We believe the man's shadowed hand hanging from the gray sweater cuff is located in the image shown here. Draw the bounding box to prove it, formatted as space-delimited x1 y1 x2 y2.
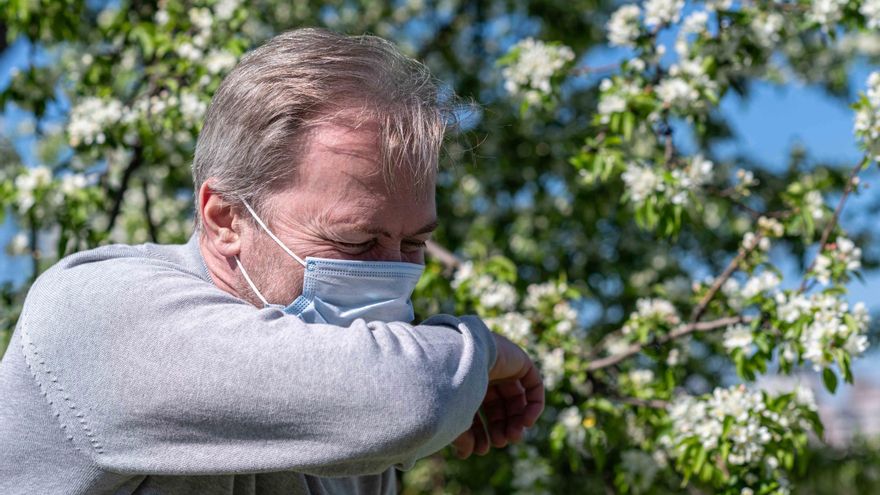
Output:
452 333 544 459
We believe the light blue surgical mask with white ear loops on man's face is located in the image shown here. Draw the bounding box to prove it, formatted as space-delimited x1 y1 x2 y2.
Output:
235 202 425 326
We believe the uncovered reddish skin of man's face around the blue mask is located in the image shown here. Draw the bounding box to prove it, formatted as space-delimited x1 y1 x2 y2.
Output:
237 120 437 305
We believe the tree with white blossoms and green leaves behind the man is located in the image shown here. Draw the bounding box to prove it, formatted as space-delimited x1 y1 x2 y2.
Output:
0 0 880 494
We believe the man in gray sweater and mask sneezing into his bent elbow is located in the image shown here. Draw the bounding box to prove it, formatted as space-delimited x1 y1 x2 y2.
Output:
0 29 544 494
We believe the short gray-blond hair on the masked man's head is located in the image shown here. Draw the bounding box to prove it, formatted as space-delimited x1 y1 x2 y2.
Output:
193 28 453 228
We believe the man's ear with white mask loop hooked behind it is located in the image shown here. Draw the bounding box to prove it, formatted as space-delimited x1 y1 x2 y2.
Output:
199 179 243 258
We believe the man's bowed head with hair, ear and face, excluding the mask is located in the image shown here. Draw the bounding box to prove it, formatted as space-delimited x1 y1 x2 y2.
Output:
193 29 447 304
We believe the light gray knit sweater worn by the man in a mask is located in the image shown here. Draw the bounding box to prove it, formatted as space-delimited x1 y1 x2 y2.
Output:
0 237 496 495
